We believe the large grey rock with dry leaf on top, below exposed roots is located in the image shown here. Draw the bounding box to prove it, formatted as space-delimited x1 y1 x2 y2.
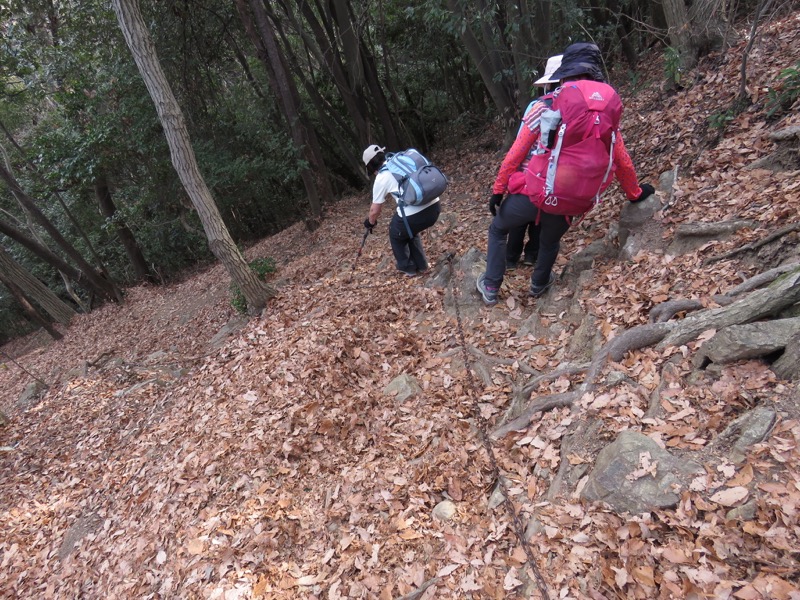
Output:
581 430 703 514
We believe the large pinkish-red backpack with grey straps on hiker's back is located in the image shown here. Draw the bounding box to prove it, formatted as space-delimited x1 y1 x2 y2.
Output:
525 80 622 216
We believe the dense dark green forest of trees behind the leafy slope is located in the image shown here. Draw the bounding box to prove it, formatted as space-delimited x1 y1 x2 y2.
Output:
0 0 780 336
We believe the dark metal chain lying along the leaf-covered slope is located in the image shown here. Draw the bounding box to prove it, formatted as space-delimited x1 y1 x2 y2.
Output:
442 254 550 600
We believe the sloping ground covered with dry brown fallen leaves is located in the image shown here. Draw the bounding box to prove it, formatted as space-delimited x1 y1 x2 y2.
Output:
0 15 800 600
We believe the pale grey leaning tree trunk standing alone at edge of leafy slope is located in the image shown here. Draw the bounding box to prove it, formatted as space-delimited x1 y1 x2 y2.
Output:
112 0 275 315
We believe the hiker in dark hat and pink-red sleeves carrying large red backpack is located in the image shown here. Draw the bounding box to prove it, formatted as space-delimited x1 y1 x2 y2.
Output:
477 43 655 306
